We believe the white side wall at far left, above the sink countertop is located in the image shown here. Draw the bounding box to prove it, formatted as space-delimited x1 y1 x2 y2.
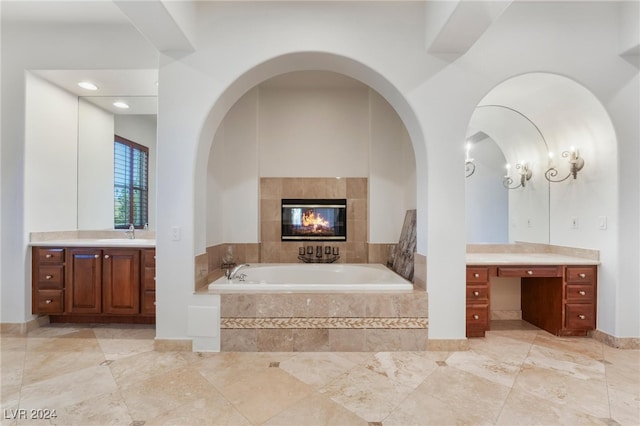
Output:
24 73 78 234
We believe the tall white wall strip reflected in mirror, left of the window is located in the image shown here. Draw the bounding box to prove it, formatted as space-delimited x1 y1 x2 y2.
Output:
76 99 114 229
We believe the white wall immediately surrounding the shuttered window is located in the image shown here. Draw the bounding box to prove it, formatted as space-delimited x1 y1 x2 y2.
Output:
114 114 158 229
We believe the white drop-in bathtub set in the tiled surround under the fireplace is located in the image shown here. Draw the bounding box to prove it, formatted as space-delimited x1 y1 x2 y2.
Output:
208 263 413 292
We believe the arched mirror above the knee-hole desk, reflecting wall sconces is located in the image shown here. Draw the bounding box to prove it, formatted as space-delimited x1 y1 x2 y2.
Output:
466 96 549 244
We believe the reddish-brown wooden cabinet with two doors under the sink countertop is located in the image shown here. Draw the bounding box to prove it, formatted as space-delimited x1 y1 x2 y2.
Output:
32 247 155 322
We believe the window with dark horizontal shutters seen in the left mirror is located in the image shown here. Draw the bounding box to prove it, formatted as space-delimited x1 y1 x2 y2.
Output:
113 135 149 229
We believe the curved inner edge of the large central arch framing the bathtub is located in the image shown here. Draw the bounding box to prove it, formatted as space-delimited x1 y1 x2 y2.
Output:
194 52 426 260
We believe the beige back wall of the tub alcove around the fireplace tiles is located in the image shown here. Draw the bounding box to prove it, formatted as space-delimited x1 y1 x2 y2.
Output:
207 84 415 246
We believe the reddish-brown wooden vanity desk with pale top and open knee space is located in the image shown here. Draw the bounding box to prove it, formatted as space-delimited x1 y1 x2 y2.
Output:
466 253 598 337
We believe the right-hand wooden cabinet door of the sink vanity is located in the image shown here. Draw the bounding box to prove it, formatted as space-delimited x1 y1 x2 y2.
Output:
102 249 140 314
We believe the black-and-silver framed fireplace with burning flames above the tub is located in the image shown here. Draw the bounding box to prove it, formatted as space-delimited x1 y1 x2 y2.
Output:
282 198 347 241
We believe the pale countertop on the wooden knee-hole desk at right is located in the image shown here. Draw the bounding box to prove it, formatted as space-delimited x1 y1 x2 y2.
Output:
467 253 600 266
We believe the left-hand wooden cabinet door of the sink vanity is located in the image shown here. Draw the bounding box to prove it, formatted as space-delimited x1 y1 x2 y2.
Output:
65 248 102 314
